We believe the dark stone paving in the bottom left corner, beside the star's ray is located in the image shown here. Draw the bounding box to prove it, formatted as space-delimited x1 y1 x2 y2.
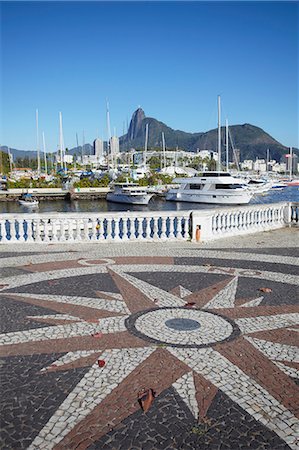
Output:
0 353 88 449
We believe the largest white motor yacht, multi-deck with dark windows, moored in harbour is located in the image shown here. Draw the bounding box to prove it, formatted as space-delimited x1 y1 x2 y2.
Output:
166 171 253 205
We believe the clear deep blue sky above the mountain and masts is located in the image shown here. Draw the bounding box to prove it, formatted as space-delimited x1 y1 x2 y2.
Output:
1 1 299 151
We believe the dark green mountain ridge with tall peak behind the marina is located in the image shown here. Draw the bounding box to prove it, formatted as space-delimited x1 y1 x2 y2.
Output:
120 108 298 161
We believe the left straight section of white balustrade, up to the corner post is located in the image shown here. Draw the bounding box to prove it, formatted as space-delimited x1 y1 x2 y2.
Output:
0 211 190 244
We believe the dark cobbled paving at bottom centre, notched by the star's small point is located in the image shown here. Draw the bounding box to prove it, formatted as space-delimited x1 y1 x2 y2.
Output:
88 388 289 450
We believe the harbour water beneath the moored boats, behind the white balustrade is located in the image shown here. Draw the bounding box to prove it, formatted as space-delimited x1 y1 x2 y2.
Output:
0 186 299 214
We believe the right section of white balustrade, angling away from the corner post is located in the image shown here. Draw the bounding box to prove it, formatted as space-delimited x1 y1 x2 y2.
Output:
192 203 299 242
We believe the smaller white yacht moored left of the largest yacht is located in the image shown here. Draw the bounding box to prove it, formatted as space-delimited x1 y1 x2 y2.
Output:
106 183 154 205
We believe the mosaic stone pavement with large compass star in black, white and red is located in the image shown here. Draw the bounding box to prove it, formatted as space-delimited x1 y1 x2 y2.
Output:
0 230 299 450
